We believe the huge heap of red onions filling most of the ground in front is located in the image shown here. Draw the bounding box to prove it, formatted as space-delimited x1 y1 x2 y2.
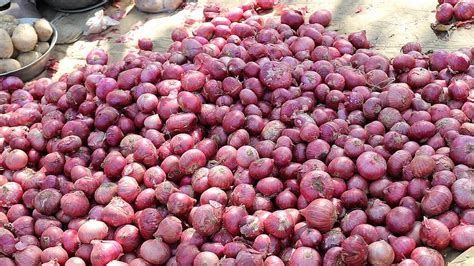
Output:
0 0 474 266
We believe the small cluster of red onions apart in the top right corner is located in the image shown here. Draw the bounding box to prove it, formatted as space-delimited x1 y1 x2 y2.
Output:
435 0 474 24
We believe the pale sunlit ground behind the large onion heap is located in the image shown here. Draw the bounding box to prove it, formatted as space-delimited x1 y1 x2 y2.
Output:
46 0 474 77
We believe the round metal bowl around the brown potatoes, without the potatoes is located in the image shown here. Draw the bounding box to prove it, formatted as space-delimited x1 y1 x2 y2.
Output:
0 18 58 81
